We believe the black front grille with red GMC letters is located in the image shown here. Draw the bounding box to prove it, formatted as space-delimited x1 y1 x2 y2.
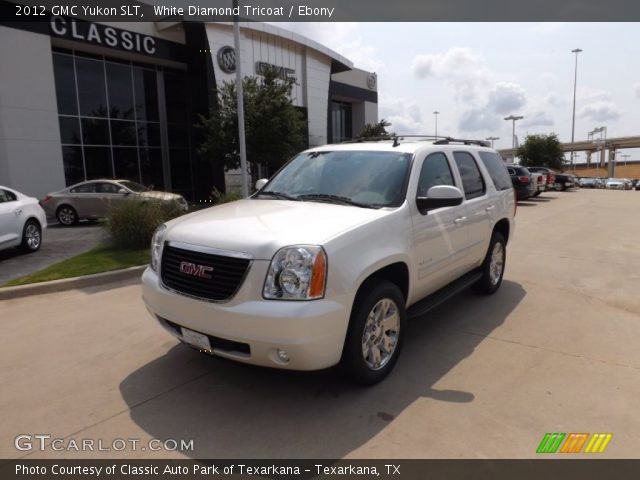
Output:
160 245 251 302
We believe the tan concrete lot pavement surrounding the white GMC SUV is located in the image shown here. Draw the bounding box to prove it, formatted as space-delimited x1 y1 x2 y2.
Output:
0 190 640 458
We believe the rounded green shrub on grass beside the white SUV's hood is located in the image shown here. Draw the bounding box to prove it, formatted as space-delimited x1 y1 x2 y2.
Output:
107 200 184 248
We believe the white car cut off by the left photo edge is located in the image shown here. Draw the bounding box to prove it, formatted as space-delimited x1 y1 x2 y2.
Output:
0 185 47 252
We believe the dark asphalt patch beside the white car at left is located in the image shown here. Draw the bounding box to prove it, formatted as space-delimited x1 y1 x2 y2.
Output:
0 222 105 285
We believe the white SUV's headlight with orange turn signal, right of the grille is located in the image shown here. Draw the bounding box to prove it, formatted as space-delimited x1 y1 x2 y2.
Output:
262 245 327 300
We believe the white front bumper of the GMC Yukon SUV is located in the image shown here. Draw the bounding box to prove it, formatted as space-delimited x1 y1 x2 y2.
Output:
142 268 353 370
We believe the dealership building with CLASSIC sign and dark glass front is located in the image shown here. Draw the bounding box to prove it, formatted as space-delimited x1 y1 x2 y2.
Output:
0 15 378 202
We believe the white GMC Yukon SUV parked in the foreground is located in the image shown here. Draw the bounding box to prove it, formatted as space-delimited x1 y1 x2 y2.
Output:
142 137 515 384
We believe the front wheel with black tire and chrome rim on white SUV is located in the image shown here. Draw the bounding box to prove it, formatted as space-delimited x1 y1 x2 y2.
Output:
340 280 407 385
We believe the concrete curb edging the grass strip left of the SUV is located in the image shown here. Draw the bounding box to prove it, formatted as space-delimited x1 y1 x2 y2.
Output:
0 265 147 300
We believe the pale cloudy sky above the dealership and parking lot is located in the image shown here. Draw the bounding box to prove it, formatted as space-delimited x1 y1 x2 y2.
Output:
278 22 640 161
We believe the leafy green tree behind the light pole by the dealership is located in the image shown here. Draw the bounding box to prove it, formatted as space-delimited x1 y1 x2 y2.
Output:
198 67 308 182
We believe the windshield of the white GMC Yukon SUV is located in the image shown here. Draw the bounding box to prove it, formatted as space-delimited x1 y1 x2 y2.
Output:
260 150 411 207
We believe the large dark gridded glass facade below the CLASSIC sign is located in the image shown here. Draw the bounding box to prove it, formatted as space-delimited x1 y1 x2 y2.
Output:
53 49 193 199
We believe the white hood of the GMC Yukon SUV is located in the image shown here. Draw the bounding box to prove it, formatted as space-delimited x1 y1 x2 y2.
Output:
165 199 392 260
